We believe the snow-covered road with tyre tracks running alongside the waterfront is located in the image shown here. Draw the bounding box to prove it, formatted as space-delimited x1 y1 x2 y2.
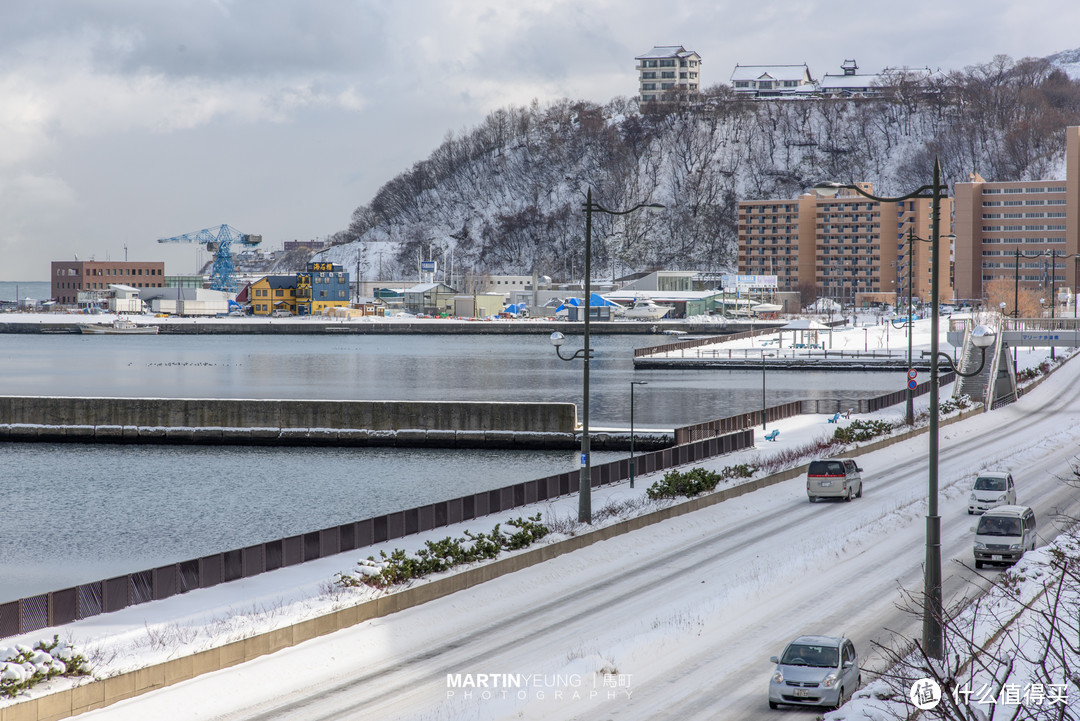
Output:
65 349 1080 721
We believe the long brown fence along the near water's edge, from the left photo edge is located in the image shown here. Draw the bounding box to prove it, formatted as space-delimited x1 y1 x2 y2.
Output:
0 428 754 638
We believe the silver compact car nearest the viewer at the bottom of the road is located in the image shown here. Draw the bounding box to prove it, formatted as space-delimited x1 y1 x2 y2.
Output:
769 636 862 708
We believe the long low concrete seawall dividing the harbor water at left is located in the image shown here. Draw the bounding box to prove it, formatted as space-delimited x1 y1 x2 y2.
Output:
0 396 577 448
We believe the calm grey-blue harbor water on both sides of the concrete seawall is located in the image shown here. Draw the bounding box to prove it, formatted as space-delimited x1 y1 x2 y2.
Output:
0 335 905 602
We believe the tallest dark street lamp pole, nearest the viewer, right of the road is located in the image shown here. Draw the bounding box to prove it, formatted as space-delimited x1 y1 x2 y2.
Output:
814 159 948 658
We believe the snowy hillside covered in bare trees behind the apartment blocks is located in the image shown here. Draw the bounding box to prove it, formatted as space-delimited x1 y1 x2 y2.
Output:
323 51 1080 284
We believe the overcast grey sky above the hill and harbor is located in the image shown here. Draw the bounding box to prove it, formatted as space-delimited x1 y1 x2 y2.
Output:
0 0 1080 281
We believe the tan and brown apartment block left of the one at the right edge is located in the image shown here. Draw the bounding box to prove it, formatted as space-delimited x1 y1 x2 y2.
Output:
739 182 951 305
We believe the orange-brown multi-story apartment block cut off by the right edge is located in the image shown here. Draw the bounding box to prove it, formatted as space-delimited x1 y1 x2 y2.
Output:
955 126 1080 303
